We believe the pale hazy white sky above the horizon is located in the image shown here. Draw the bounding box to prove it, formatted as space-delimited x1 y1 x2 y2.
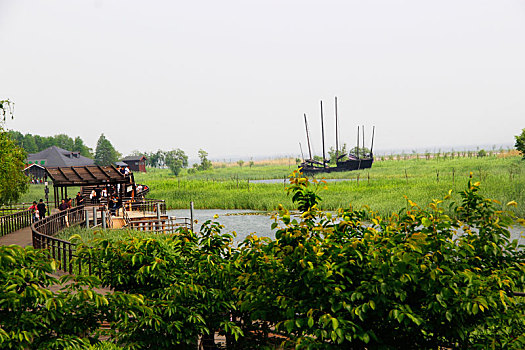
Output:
0 0 525 159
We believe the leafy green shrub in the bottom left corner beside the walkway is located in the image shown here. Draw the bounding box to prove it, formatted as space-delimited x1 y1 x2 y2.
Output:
0 246 146 349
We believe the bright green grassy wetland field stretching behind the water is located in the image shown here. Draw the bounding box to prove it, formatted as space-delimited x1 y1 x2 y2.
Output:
135 156 525 217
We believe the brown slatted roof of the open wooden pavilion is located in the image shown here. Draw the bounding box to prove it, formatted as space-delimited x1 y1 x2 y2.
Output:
46 165 130 186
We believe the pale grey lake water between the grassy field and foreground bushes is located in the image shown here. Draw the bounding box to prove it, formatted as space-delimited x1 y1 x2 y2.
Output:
167 209 525 244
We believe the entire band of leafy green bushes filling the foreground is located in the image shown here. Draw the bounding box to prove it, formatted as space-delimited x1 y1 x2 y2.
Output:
4 171 525 349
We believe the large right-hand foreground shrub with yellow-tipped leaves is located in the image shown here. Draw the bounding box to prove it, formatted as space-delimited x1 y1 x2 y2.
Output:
235 174 525 349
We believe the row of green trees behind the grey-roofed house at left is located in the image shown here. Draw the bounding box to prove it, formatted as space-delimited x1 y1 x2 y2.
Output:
8 130 94 158
